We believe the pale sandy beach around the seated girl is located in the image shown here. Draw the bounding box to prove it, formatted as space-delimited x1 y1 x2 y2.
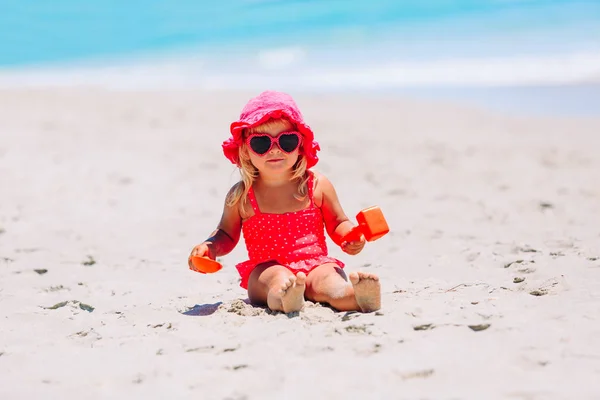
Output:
0 88 600 399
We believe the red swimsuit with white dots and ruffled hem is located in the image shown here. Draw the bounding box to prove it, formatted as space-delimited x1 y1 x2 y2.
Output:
236 172 344 289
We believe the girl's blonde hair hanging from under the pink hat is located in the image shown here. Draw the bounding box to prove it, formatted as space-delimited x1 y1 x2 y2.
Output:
226 119 308 218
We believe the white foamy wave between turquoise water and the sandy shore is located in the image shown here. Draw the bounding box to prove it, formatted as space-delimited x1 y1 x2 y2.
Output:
0 47 600 90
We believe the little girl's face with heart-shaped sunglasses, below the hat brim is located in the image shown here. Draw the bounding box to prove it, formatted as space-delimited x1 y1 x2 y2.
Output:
245 121 301 174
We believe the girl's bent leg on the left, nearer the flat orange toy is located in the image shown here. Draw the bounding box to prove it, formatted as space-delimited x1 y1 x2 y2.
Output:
248 262 306 313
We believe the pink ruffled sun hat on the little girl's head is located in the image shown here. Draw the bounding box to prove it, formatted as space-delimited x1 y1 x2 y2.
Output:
222 91 321 168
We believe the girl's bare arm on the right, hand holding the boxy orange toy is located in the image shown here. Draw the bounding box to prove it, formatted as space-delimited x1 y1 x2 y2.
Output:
315 174 365 254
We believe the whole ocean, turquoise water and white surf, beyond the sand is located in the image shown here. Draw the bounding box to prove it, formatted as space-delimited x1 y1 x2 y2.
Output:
0 0 600 114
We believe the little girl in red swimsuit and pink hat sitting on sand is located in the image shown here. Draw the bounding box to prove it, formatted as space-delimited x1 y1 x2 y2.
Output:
188 91 381 313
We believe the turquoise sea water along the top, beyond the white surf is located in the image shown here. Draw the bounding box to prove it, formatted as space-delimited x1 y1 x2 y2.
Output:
0 0 600 66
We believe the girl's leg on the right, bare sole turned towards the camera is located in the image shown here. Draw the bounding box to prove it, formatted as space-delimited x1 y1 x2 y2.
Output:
305 263 381 312
